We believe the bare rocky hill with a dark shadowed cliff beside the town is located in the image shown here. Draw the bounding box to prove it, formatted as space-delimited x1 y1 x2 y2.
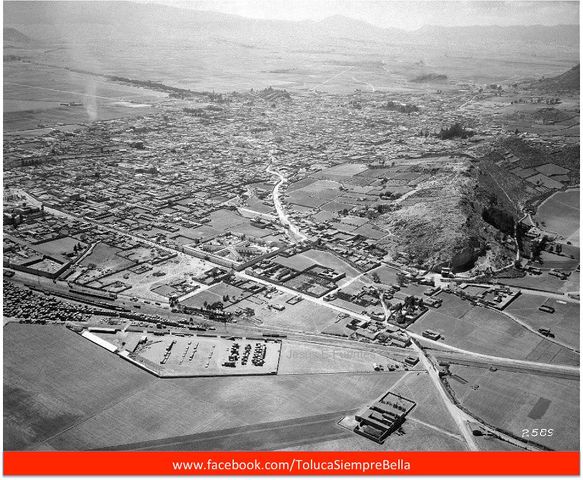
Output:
377 159 513 271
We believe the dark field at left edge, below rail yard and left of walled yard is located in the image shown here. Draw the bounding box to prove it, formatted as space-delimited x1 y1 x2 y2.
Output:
4 323 153 450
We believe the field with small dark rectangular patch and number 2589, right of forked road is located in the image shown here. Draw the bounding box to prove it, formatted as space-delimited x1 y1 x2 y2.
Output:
449 365 579 450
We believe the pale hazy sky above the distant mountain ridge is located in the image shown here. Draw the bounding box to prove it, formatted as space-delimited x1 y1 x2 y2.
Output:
137 0 579 30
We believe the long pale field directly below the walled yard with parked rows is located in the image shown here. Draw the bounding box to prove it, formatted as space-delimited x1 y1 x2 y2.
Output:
36 370 400 450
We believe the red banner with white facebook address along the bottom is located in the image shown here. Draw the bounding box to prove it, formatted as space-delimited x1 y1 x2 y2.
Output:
4 452 579 475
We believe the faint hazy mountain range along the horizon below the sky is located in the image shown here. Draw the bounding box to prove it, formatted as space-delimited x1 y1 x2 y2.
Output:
3 1 579 48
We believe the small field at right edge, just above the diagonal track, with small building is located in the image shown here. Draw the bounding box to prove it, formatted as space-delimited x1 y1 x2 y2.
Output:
507 294 580 348
